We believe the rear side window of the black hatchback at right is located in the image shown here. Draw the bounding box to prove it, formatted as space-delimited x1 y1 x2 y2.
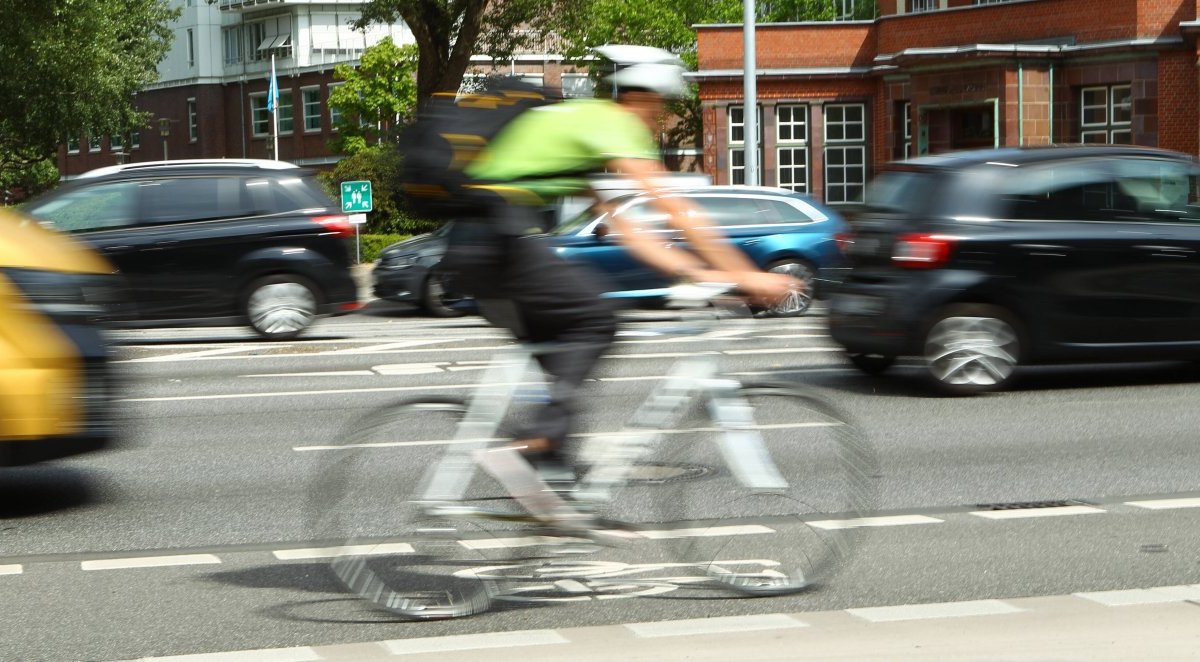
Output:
1000 160 1138 221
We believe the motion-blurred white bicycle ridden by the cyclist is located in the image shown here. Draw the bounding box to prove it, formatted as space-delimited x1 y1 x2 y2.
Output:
318 284 875 620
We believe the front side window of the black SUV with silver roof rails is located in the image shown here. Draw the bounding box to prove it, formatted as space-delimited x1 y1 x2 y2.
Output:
26 181 137 233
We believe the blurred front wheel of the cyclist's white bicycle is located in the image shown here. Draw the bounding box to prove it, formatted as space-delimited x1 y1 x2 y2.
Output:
648 385 877 595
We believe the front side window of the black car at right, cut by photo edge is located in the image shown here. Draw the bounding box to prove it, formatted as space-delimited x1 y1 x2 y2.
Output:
1112 158 1200 223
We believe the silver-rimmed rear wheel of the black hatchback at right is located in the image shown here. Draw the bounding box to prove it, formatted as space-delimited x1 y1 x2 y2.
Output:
925 305 1021 395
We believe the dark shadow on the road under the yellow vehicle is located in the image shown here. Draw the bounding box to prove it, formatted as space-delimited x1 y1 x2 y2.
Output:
0 464 100 519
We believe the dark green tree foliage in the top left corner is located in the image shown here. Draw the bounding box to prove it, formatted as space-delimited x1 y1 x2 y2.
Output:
0 0 180 199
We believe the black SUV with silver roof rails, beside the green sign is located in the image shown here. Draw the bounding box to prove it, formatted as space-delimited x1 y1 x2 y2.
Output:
26 160 359 339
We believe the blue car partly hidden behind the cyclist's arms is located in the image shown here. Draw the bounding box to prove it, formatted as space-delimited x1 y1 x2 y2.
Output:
535 186 848 317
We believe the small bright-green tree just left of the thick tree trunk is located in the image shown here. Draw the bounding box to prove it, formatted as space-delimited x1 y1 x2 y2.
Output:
329 37 416 155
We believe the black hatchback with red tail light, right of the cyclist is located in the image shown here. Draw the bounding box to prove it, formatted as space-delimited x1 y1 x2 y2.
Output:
829 146 1200 393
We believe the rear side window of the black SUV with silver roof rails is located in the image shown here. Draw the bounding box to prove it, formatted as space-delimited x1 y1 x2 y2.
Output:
138 176 250 223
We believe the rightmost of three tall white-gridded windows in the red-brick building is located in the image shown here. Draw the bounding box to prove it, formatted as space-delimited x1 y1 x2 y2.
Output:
824 103 866 204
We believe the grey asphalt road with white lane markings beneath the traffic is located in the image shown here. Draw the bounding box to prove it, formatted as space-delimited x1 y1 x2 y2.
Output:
0 302 1200 661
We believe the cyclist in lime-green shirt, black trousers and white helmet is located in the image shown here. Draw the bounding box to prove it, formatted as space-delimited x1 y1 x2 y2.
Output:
443 46 803 507
